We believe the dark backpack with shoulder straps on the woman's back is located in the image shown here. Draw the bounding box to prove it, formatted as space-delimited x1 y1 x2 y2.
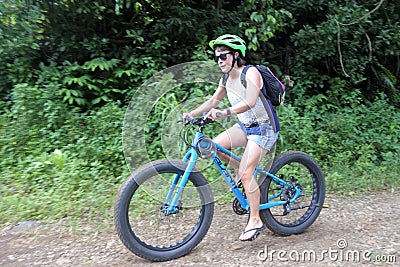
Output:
222 65 285 106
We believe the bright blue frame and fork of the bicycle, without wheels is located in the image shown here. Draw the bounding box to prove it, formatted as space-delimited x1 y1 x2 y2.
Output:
164 127 301 214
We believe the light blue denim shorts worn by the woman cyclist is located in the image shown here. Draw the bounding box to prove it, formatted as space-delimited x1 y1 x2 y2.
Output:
234 122 278 151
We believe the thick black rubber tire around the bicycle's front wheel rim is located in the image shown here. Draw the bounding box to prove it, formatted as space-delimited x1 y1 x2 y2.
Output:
114 160 214 261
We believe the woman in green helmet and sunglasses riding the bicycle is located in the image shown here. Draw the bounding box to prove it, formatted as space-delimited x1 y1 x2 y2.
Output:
183 34 279 241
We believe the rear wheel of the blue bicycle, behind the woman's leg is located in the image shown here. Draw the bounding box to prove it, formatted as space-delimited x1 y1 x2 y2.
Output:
260 151 325 235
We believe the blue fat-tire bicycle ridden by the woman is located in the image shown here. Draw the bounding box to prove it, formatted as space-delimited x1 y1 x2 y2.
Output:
114 118 325 261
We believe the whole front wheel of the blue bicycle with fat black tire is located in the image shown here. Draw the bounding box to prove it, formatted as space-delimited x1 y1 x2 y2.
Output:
114 160 214 261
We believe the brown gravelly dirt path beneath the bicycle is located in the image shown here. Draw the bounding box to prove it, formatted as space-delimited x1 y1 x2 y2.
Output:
0 192 400 267
